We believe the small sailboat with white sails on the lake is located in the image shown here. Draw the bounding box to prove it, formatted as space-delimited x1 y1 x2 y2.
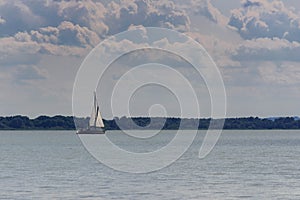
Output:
77 92 105 134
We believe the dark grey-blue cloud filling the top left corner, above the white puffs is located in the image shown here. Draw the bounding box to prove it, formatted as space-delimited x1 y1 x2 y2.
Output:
0 0 107 36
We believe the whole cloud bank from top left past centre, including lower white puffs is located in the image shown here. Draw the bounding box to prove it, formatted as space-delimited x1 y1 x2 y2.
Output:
0 0 190 58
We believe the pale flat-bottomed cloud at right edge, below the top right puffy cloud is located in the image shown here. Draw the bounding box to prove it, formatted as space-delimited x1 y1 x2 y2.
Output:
225 38 300 86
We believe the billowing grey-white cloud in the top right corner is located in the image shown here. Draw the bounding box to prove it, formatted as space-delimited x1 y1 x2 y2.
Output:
228 0 300 42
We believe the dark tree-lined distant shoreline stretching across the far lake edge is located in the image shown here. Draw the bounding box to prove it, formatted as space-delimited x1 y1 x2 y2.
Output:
0 115 300 130
